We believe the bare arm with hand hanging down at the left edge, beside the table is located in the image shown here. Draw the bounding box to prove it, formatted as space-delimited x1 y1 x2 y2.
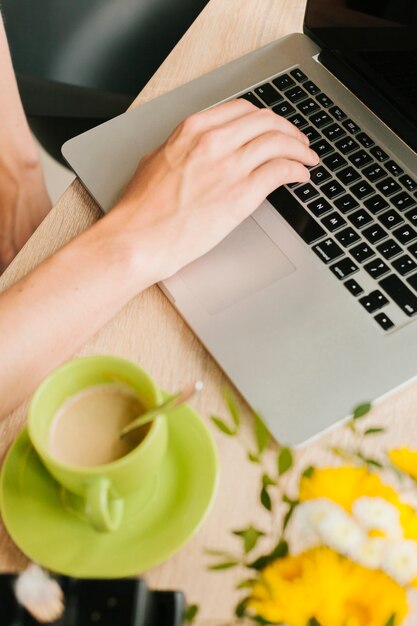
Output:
0 15 51 273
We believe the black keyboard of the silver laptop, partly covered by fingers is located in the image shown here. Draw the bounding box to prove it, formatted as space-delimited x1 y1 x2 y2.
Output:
240 68 417 331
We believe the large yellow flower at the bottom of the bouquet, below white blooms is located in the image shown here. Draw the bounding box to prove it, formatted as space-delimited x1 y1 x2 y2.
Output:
248 547 408 626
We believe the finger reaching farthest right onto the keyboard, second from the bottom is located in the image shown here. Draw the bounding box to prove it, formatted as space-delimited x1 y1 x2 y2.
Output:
237 131 320 172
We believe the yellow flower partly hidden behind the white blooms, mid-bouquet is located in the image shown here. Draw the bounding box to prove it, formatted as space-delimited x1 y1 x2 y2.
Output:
299 466 417 540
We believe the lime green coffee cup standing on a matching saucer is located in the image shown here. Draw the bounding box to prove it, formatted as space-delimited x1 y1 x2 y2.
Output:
28 356 168 532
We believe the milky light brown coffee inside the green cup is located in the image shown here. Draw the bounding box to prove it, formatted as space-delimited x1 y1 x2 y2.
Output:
48 384 150 467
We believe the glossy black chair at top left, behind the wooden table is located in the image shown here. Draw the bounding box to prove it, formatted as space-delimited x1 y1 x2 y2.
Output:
2 0 208 163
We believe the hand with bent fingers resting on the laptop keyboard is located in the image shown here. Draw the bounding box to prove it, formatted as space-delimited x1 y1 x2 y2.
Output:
109 99 319 281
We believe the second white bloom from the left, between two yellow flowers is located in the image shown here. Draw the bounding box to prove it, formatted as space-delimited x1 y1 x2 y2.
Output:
317 505 366 555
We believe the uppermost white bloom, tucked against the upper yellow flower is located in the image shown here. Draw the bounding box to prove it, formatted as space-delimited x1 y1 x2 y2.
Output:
352 497 403 539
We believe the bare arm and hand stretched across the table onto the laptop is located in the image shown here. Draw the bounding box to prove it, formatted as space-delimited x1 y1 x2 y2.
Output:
0 100 318 416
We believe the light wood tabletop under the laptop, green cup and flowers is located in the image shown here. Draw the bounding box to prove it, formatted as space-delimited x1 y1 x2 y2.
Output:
0 0 417 618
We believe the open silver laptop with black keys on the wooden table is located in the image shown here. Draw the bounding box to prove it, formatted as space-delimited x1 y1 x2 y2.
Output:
63 0 417 445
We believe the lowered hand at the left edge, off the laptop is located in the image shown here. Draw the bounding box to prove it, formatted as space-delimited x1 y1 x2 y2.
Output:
0 152 51 274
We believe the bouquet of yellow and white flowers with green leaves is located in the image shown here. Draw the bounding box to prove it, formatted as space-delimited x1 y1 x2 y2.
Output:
190 393 417 626
